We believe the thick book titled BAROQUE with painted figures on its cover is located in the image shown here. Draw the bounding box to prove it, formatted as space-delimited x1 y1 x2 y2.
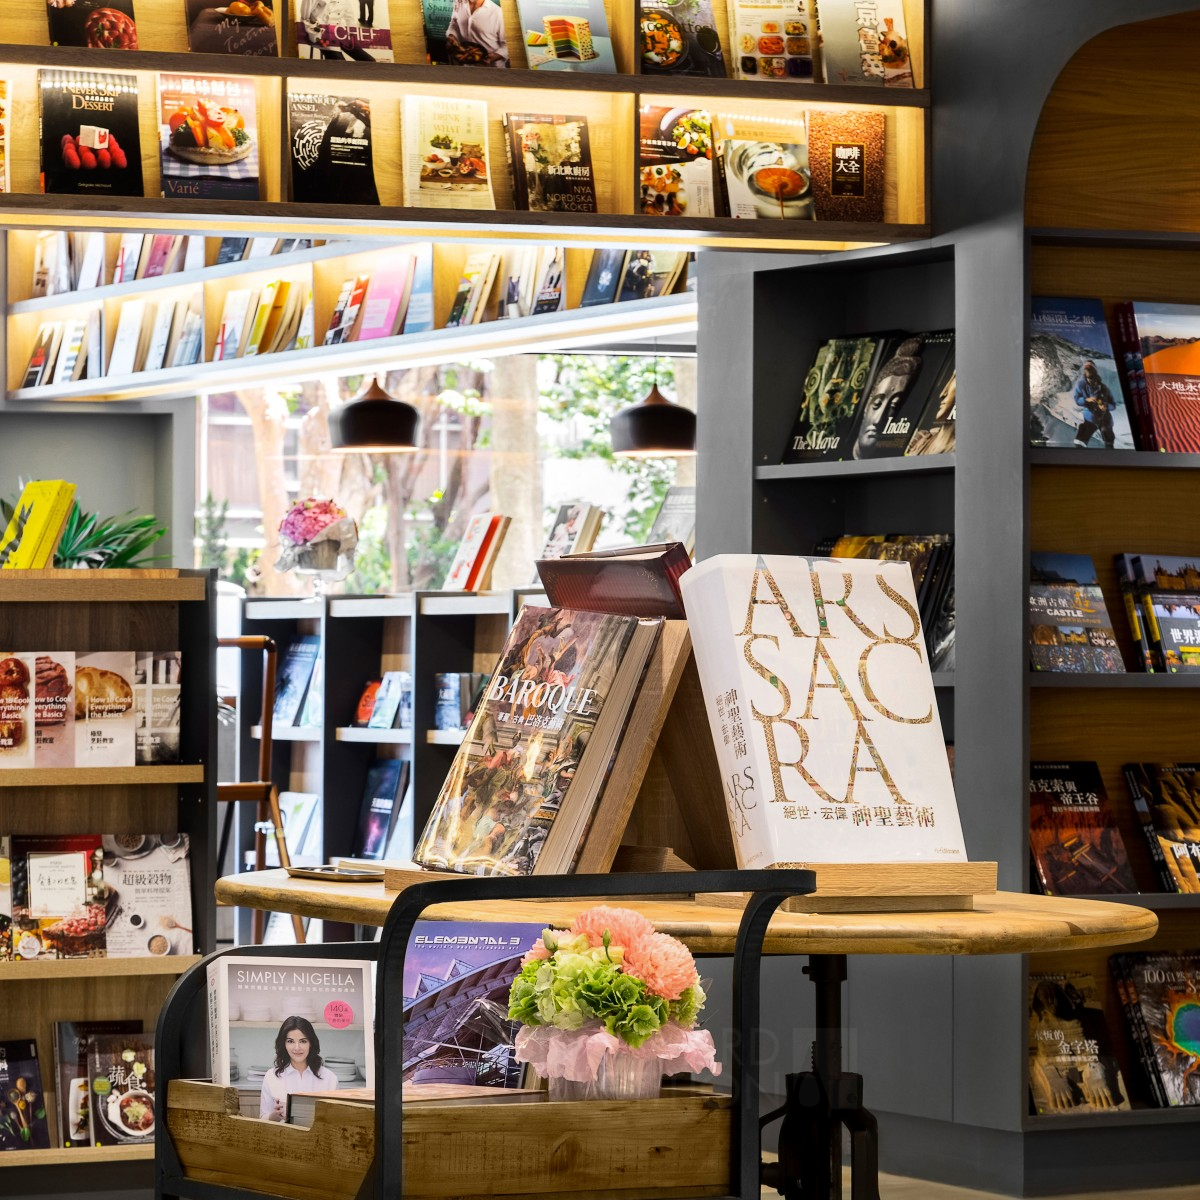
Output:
413 604 660 875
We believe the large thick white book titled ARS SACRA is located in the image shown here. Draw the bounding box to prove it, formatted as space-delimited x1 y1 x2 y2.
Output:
679 554 966 870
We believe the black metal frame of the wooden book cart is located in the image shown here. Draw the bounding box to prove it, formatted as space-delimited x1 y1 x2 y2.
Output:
155 870 816 1200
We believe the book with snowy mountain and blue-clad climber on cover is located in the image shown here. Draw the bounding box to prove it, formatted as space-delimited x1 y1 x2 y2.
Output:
1030 296 1134 450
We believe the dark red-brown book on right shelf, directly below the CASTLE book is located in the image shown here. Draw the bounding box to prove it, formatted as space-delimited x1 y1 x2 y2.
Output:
1030 761 1138 896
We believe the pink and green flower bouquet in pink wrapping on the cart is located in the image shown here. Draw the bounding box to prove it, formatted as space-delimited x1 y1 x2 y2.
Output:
509 906 721 1100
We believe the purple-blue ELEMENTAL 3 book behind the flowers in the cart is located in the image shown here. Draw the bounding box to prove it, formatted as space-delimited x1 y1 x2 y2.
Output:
401 920 541 1087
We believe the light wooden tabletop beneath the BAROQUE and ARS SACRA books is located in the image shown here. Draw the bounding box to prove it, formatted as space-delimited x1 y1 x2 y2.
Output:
216 870 1158 954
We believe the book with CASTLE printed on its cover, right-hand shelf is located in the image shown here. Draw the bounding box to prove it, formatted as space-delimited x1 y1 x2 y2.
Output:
1030 551 1124 673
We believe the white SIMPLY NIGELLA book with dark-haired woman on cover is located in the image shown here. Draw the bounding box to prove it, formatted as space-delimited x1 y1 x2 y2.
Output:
208 954 374 1117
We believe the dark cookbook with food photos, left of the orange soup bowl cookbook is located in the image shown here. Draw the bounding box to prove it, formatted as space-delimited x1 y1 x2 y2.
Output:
637 104 724 217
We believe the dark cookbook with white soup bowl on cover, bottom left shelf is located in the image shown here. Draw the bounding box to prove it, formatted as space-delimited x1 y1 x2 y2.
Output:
88 1033 155 1146
